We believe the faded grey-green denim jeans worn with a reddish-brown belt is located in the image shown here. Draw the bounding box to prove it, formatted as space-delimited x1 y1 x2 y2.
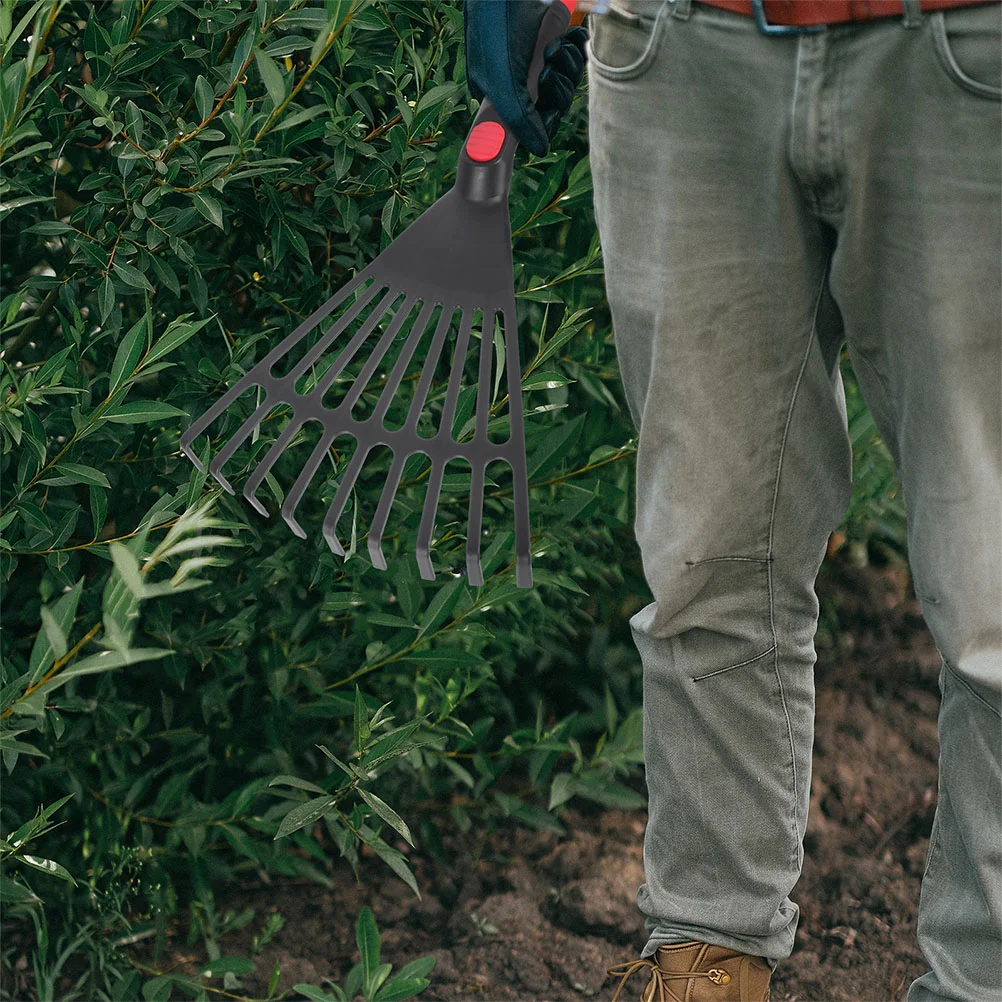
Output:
588 0 1002 1002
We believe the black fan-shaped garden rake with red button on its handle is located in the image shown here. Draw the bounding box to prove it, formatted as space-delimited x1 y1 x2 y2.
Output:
180 0 574 588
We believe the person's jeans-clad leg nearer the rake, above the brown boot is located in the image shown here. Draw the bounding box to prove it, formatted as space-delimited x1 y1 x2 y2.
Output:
589 0 852 969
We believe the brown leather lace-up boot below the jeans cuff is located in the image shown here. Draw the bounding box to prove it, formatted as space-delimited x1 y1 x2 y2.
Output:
606 940 773 1002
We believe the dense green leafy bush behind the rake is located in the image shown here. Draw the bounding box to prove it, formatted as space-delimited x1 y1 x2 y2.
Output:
0 0 900 999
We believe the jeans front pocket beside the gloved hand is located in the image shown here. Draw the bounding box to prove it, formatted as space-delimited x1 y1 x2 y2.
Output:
588 0 672 80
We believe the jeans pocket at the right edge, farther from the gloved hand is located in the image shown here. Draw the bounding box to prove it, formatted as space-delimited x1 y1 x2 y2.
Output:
930 3 1002 101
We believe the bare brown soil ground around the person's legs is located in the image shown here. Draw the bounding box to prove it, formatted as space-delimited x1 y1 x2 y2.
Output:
135 564 940 1002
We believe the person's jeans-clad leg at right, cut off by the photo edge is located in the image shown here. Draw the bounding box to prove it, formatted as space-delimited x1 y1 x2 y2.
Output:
832 5 1002 1002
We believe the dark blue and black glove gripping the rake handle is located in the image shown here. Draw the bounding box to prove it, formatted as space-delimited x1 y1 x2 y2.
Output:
463 0 588 156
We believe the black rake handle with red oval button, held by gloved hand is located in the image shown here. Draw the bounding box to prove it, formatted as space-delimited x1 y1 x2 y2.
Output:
456 0 575 202
